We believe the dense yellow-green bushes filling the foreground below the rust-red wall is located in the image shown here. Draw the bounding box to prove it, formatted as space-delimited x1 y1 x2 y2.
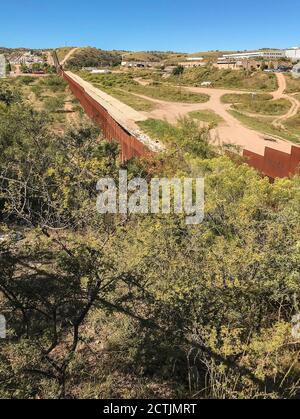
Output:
0 82 300 399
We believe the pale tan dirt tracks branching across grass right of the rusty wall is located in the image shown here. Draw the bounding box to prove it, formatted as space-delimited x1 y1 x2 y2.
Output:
67 72 300 155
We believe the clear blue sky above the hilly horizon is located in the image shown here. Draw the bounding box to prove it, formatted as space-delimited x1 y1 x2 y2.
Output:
0 0 300 52
